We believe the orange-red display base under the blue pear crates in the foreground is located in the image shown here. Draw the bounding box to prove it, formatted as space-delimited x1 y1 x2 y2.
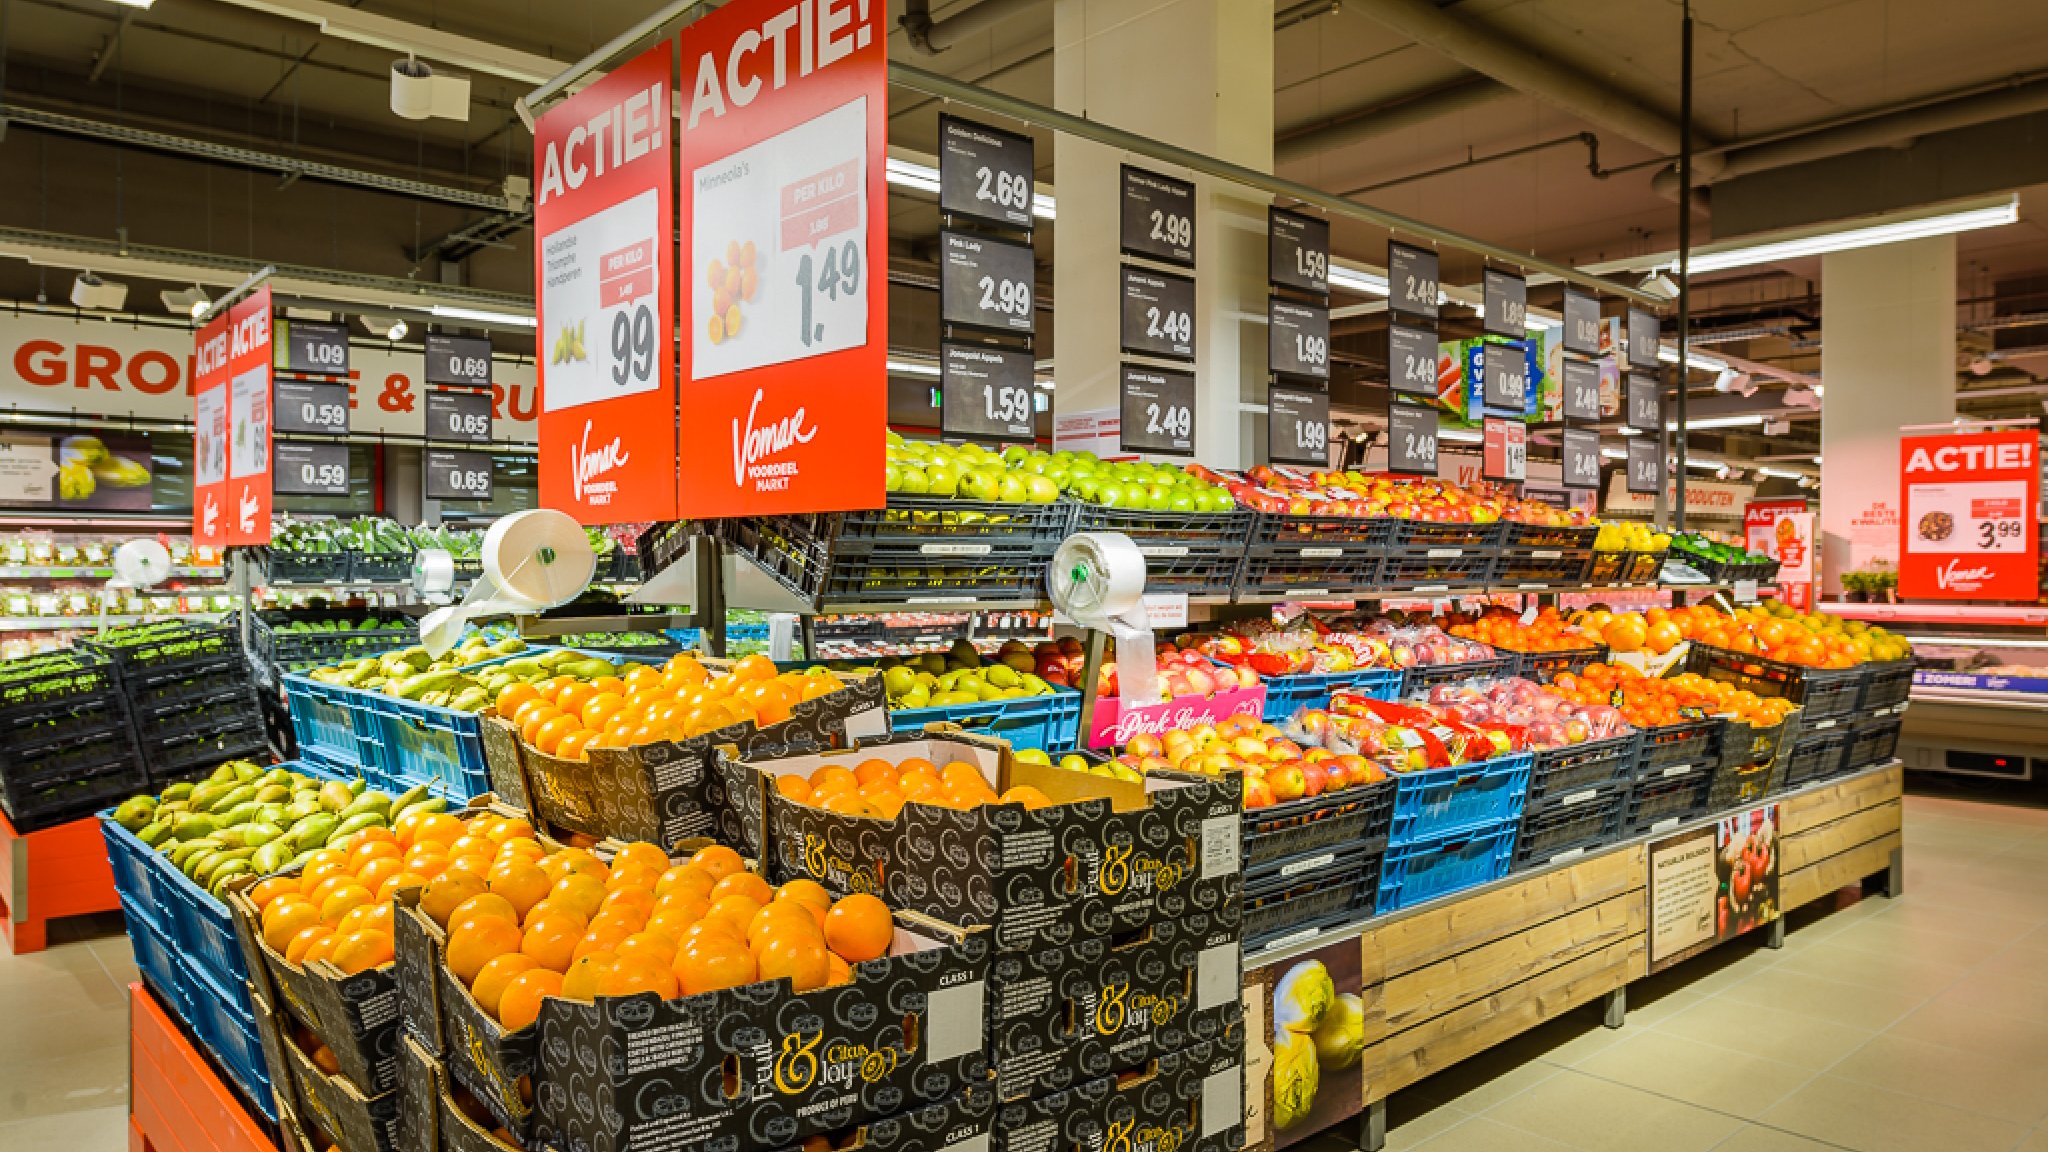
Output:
129 980 279 1152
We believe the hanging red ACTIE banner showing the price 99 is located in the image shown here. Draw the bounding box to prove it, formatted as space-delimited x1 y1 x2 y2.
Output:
532 43 676 525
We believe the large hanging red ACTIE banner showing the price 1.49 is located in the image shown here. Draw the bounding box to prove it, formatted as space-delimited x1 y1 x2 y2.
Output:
678 0 889 517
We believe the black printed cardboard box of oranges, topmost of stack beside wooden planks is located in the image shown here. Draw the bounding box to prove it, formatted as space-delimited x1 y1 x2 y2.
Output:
719 726 1243 951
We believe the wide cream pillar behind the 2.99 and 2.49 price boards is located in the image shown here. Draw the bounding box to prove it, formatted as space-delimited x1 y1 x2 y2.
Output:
1053 0 1274 465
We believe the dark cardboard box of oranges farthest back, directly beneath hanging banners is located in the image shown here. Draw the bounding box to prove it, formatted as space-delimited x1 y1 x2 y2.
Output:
483 658 889 847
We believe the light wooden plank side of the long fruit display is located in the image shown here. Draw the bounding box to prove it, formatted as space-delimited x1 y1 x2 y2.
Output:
1245 760 1905 1152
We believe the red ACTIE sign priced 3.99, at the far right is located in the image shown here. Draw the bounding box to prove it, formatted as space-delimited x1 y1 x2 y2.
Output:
1898 428 2042 601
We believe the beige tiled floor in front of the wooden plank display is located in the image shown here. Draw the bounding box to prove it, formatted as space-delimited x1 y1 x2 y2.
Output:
1303 795 2048 1152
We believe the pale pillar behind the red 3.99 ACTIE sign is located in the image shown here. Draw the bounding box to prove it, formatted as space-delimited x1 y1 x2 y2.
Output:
1821 236 1956 592
